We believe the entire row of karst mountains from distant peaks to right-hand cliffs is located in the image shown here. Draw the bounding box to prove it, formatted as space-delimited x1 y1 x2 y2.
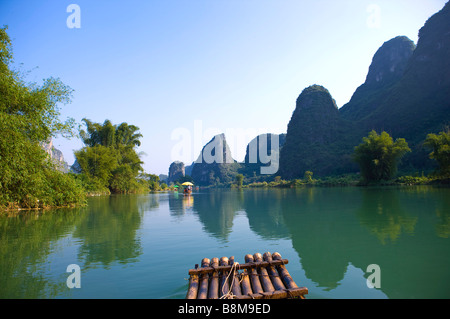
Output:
169 2 450 185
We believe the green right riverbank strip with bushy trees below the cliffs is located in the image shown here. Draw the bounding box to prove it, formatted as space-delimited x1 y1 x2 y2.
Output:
229 129 450 188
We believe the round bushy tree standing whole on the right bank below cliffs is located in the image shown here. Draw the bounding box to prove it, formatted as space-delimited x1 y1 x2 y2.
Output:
354 131 411 182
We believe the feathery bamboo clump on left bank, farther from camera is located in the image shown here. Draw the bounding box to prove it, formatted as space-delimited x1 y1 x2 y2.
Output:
75 119 144 193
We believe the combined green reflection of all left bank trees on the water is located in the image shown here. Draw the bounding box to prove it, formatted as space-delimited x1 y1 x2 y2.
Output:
0 196 151 299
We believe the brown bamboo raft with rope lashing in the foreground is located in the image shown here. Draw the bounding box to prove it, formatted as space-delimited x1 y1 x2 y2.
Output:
186 252 308 299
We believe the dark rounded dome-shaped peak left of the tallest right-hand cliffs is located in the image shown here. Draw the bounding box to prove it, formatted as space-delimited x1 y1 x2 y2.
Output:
280 85 351 179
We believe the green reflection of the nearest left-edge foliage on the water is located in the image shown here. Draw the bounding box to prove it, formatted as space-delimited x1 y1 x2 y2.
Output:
0 209 83 299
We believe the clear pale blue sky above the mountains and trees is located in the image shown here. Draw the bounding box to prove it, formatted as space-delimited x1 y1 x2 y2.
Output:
0 0 447 174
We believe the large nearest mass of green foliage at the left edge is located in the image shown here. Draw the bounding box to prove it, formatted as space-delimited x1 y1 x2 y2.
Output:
0 28 85 208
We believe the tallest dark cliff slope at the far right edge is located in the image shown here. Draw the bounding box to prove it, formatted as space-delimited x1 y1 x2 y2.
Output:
366 2 450 143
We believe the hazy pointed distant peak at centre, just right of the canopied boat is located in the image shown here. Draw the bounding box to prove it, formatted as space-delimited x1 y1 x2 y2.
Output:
191 134 239 185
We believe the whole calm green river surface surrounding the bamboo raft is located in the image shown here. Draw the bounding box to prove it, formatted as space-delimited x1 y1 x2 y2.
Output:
0 186 450 299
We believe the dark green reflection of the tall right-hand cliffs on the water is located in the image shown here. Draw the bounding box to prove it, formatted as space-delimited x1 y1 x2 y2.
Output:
283 188 450 298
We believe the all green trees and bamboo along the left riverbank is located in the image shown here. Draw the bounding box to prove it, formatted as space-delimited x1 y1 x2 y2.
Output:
0 27 164 210
